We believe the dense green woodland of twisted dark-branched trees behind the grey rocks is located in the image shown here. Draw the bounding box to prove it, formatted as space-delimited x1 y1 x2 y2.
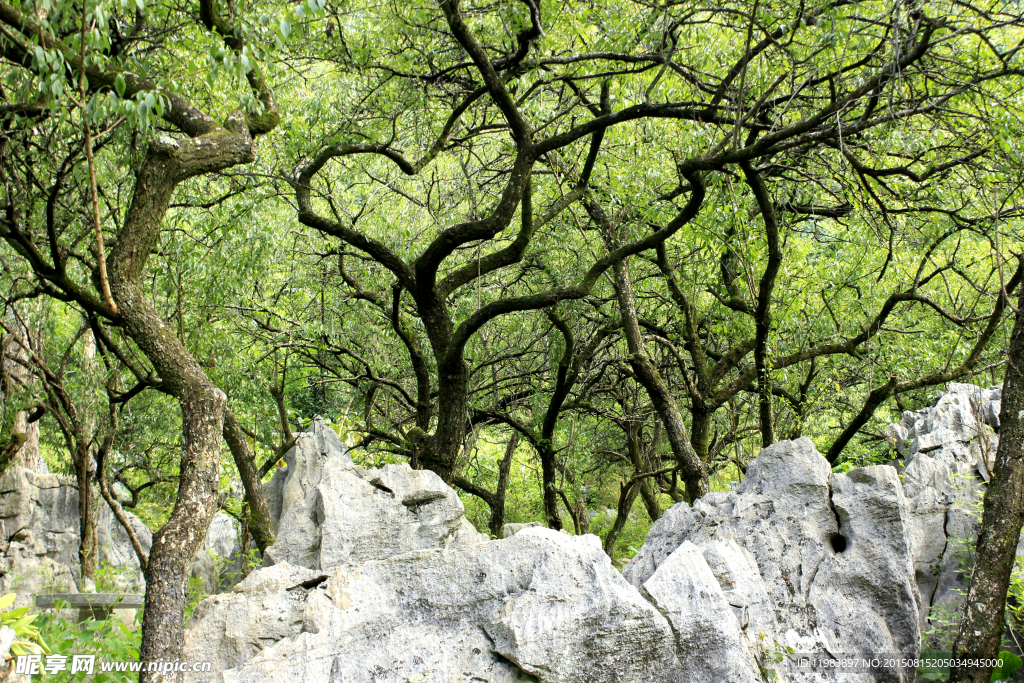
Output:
0 0 1024 679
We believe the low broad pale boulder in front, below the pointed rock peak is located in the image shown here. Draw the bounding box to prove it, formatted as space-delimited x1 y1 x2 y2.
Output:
183 528 682 683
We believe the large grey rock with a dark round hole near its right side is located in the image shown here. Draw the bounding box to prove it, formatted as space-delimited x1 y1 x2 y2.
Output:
624 438 921 681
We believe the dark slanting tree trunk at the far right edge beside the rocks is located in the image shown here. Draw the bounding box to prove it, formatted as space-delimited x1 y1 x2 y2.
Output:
949 278 1024 683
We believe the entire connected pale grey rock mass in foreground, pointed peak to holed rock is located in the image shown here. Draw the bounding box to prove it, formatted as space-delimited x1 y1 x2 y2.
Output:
183 425 920 683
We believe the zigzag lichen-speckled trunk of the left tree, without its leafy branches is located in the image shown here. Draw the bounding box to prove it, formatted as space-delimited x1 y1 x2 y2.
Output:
109 118 260 683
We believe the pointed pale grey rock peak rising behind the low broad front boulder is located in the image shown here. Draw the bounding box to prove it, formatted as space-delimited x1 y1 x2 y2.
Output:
263 420 487 569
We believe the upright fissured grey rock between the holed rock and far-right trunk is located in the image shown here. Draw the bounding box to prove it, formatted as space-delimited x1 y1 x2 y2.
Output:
887 383 1001 643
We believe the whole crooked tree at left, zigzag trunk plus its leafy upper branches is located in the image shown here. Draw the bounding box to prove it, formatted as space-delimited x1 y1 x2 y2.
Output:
0 2 280 681
